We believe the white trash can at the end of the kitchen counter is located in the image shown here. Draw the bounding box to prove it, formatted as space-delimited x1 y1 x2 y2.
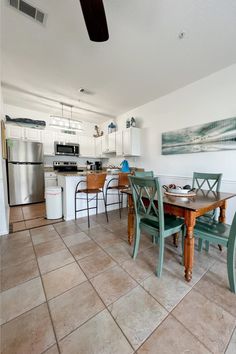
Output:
45 187 62 219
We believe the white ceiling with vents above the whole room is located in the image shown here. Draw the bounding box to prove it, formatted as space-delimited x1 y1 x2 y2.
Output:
1 0 236 121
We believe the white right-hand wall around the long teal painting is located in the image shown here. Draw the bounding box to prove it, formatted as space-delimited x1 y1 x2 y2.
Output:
114 64 236 222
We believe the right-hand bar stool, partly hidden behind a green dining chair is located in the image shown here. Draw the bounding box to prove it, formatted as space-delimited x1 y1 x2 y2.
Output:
105 172 130 218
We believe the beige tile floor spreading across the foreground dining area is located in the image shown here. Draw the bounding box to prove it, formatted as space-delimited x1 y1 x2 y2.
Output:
0 210 236 354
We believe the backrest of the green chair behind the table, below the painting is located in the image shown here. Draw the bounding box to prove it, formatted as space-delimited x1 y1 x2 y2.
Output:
192 172 222 192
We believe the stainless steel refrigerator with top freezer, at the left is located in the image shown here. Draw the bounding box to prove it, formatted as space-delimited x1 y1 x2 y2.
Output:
7 139 44 206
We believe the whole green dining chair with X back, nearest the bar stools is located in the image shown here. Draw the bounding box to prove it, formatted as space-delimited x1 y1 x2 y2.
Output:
129 176 183 277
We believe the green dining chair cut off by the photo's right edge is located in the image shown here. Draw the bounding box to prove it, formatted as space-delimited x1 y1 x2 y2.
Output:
194 213 236 293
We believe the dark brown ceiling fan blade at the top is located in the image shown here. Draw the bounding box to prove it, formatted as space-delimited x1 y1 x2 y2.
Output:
80 0 109 42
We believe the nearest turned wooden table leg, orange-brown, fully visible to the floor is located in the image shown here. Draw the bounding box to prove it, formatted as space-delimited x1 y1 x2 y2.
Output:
184 210 195 282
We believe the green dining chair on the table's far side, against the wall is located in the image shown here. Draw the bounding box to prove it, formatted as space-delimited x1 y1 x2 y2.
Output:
192 172 222 252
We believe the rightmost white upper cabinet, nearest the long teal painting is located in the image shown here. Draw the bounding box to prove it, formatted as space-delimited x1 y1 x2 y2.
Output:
122 127 141 156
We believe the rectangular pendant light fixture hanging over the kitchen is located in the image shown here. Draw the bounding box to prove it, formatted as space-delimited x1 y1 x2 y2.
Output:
49 102 83 131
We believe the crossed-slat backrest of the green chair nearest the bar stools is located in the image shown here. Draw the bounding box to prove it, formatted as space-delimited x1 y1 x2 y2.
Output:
129 176 165 233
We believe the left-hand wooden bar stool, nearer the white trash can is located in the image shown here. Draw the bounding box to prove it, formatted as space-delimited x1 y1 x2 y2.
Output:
75 173 108 227
